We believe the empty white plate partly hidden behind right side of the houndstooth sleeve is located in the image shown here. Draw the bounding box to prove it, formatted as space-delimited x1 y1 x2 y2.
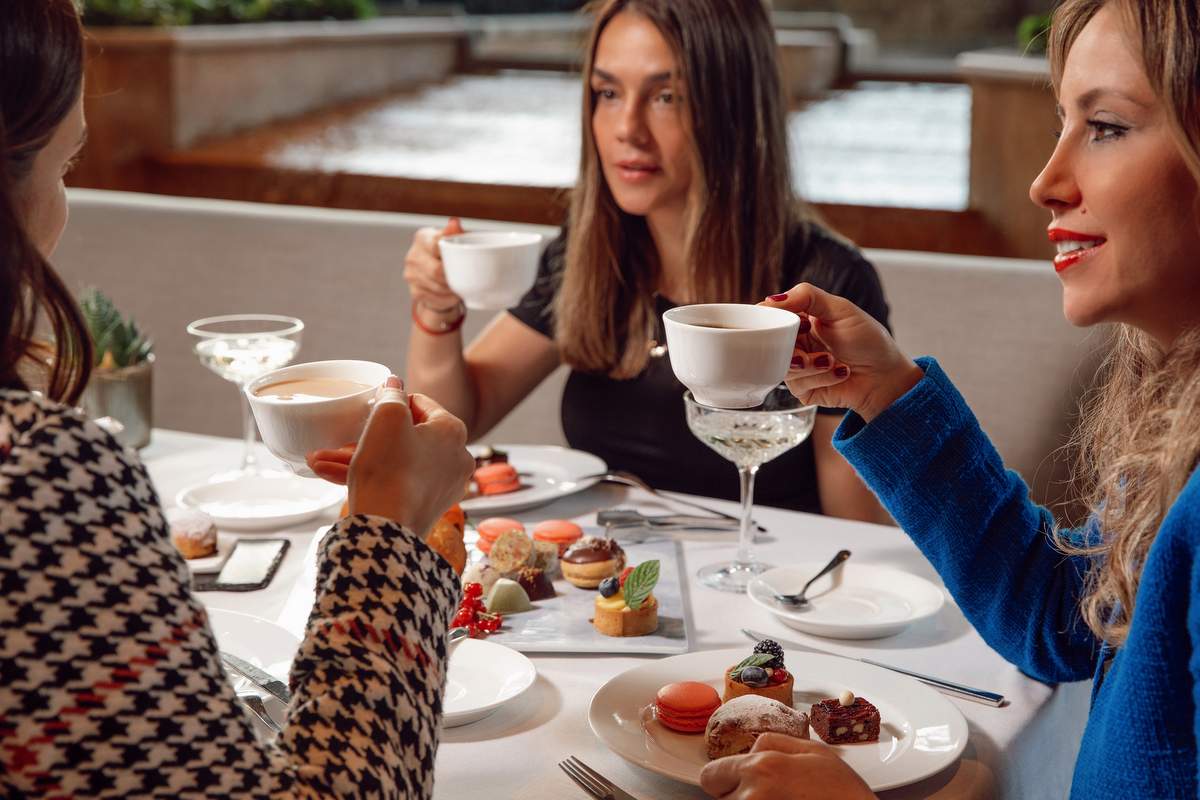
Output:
442 639 538 728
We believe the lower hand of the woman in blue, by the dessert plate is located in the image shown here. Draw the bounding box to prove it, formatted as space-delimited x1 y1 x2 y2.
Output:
700 733 875 800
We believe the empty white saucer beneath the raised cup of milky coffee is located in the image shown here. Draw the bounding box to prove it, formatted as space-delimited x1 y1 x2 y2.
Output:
175 473 346 530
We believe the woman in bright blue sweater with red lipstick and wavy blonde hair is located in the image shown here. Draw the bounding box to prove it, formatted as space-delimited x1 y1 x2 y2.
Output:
703 0 1200 800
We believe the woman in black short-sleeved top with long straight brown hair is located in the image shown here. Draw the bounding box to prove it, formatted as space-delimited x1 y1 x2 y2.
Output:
404 0 887 519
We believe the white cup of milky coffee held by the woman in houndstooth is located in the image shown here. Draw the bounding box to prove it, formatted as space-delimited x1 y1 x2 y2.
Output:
245 361 391 477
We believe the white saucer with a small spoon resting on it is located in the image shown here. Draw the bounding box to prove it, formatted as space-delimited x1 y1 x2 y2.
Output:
746 561 946 639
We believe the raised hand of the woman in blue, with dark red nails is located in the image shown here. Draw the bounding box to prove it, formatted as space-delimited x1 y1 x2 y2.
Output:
760 283 924 421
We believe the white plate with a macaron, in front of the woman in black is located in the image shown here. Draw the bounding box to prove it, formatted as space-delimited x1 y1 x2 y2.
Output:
462 444 608 517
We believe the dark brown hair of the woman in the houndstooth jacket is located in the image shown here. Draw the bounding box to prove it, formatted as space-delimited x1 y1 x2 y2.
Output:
0 0 92 404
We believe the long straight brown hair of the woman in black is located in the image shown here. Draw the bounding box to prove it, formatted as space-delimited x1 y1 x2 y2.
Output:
554 0 808 378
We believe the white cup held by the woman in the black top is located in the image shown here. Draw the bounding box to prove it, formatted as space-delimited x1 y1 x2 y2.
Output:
438 230 541 308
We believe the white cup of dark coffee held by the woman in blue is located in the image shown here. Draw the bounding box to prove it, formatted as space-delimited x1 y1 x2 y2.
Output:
662 303 800 408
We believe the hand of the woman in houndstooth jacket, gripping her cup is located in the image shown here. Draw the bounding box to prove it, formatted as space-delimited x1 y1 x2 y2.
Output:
308 375 475 534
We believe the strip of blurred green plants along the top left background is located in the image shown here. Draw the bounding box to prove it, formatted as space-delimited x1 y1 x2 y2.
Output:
83 0 377 25
